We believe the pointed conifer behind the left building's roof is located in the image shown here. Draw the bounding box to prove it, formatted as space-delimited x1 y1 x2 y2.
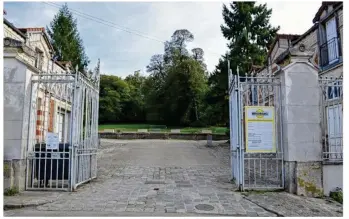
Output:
46 4 90 71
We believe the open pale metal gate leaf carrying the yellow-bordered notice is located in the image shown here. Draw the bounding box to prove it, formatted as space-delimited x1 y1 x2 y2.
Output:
229 70 284 191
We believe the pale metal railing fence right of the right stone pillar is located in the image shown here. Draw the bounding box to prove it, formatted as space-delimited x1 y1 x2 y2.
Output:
319 78 343 163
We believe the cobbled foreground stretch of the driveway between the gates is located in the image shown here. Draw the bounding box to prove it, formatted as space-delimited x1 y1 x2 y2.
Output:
29 166 275 216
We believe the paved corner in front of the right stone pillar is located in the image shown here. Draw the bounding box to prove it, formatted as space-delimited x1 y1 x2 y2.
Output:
245 192 343 217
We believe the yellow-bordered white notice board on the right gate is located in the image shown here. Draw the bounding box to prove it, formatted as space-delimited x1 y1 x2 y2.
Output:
245 106 276 153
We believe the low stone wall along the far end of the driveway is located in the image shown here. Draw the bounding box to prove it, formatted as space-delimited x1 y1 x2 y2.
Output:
99 132 229 141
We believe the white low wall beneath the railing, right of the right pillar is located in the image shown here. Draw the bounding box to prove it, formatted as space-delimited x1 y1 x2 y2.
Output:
322 164 343 196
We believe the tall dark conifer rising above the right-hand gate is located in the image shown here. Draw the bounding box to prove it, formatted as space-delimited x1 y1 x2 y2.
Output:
221 2 280 73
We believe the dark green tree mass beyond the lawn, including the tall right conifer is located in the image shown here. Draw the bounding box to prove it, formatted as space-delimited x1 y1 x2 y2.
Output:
100 2 279 128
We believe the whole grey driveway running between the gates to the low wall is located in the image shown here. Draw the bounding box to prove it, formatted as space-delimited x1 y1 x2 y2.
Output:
5 140 342 216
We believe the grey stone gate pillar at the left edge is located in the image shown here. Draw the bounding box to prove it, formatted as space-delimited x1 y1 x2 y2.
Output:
3 56 31 191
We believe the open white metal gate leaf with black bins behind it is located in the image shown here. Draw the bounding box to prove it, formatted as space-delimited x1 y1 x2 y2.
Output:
26 73 99 191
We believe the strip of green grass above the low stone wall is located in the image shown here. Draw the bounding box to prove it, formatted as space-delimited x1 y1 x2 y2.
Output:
98 124 227 134
